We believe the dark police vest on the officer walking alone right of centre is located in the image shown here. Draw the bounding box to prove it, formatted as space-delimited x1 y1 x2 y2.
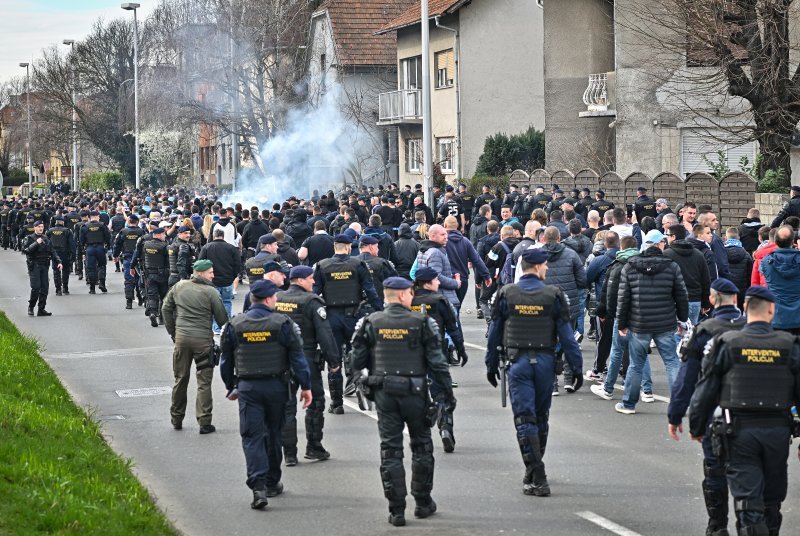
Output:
501 285 566 351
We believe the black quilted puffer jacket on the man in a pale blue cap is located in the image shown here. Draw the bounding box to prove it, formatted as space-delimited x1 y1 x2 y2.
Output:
617 247 689 334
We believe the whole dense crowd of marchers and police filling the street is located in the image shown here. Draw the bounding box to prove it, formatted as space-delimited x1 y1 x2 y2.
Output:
0 180 800 536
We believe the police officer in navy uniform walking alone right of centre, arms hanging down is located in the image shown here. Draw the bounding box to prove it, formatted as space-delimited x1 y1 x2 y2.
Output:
486 249 583 497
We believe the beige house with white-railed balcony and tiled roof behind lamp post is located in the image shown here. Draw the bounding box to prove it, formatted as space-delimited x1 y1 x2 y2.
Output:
378 0 545 184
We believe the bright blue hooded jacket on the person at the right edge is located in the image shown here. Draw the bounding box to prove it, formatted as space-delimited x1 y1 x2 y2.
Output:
760 248 800 329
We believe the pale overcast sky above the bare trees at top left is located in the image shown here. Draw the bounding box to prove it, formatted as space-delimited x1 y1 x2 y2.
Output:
0 0 158 81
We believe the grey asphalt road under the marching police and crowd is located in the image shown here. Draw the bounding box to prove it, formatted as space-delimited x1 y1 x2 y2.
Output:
0 250 800 536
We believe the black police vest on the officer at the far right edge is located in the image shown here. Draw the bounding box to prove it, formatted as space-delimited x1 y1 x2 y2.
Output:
717 331 795 412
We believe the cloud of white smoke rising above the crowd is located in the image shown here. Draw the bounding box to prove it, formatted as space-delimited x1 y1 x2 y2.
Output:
217 84 362 208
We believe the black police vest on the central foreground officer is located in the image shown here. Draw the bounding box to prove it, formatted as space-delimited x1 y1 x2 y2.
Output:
367 311 428 376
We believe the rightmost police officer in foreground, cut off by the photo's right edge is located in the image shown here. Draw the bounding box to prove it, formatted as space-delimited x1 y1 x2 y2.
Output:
689 285 800 536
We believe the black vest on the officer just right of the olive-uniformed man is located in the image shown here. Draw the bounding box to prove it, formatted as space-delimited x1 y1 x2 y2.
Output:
230 313 289 379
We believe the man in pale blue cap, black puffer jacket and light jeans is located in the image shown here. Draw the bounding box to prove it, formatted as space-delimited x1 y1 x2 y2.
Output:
614 229 689 415
